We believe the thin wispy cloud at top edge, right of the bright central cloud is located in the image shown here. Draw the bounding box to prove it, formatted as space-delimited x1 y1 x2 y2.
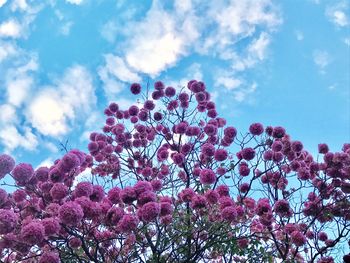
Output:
197 0 282 54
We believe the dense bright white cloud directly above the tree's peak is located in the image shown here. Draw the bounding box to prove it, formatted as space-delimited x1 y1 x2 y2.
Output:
125 1 199 77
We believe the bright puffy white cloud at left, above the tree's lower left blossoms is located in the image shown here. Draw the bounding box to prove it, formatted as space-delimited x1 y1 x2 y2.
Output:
27 65 96 136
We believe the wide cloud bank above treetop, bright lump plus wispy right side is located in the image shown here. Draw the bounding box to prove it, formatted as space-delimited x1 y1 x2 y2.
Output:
99 0 282 104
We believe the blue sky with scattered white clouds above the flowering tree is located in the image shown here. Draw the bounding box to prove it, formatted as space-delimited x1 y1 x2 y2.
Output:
0 0 350 165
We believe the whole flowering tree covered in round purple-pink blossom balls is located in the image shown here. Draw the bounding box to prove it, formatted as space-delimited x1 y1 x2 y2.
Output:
0 80 350 263
